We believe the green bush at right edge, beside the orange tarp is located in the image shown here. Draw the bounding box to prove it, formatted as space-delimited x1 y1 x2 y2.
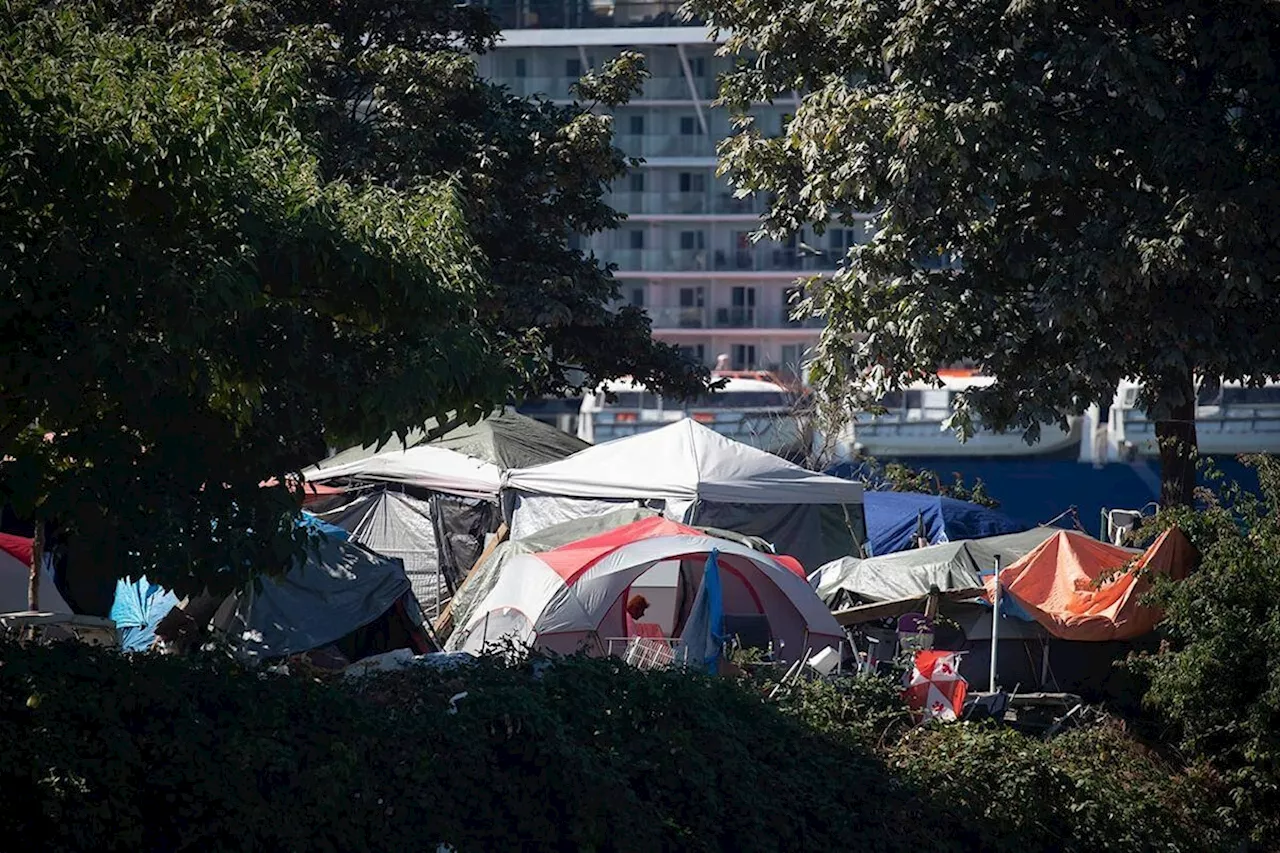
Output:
1133 456 1280 840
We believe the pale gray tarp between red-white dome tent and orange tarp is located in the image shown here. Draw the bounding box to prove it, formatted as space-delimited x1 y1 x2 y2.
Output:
813 528 1060 606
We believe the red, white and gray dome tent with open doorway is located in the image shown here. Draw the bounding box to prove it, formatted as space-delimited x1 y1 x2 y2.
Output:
456 517 844 661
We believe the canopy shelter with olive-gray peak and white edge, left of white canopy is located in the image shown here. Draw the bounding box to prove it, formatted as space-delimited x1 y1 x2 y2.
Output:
303 409 588 615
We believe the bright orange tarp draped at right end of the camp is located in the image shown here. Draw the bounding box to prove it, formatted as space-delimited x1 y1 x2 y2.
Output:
987 528 1196 640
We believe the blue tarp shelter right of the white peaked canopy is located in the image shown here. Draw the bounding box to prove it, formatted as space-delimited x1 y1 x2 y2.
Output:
863 491 1028 557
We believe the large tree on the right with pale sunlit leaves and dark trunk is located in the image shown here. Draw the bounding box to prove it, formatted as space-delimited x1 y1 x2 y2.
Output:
692 0 1280 503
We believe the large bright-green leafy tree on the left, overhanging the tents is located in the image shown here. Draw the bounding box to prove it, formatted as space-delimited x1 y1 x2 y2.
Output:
0 3 698 593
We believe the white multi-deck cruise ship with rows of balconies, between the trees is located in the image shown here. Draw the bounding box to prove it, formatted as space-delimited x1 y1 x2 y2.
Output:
479 0 867 374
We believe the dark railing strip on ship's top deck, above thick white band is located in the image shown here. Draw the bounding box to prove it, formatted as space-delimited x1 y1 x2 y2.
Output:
474 0 703 29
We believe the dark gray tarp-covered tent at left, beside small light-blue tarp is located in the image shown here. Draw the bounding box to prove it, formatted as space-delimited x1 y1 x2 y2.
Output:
212 537 410 658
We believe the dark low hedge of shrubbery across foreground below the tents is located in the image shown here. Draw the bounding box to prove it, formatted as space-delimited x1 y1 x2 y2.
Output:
0 646 1226 853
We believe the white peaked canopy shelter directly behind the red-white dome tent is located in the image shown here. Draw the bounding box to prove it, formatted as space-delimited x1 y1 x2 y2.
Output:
503 418 865 567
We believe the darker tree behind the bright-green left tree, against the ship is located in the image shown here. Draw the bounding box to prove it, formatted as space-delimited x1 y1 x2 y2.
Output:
111 0 707 398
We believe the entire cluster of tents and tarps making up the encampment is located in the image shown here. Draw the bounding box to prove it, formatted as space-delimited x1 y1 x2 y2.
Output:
0 410 1196 689
